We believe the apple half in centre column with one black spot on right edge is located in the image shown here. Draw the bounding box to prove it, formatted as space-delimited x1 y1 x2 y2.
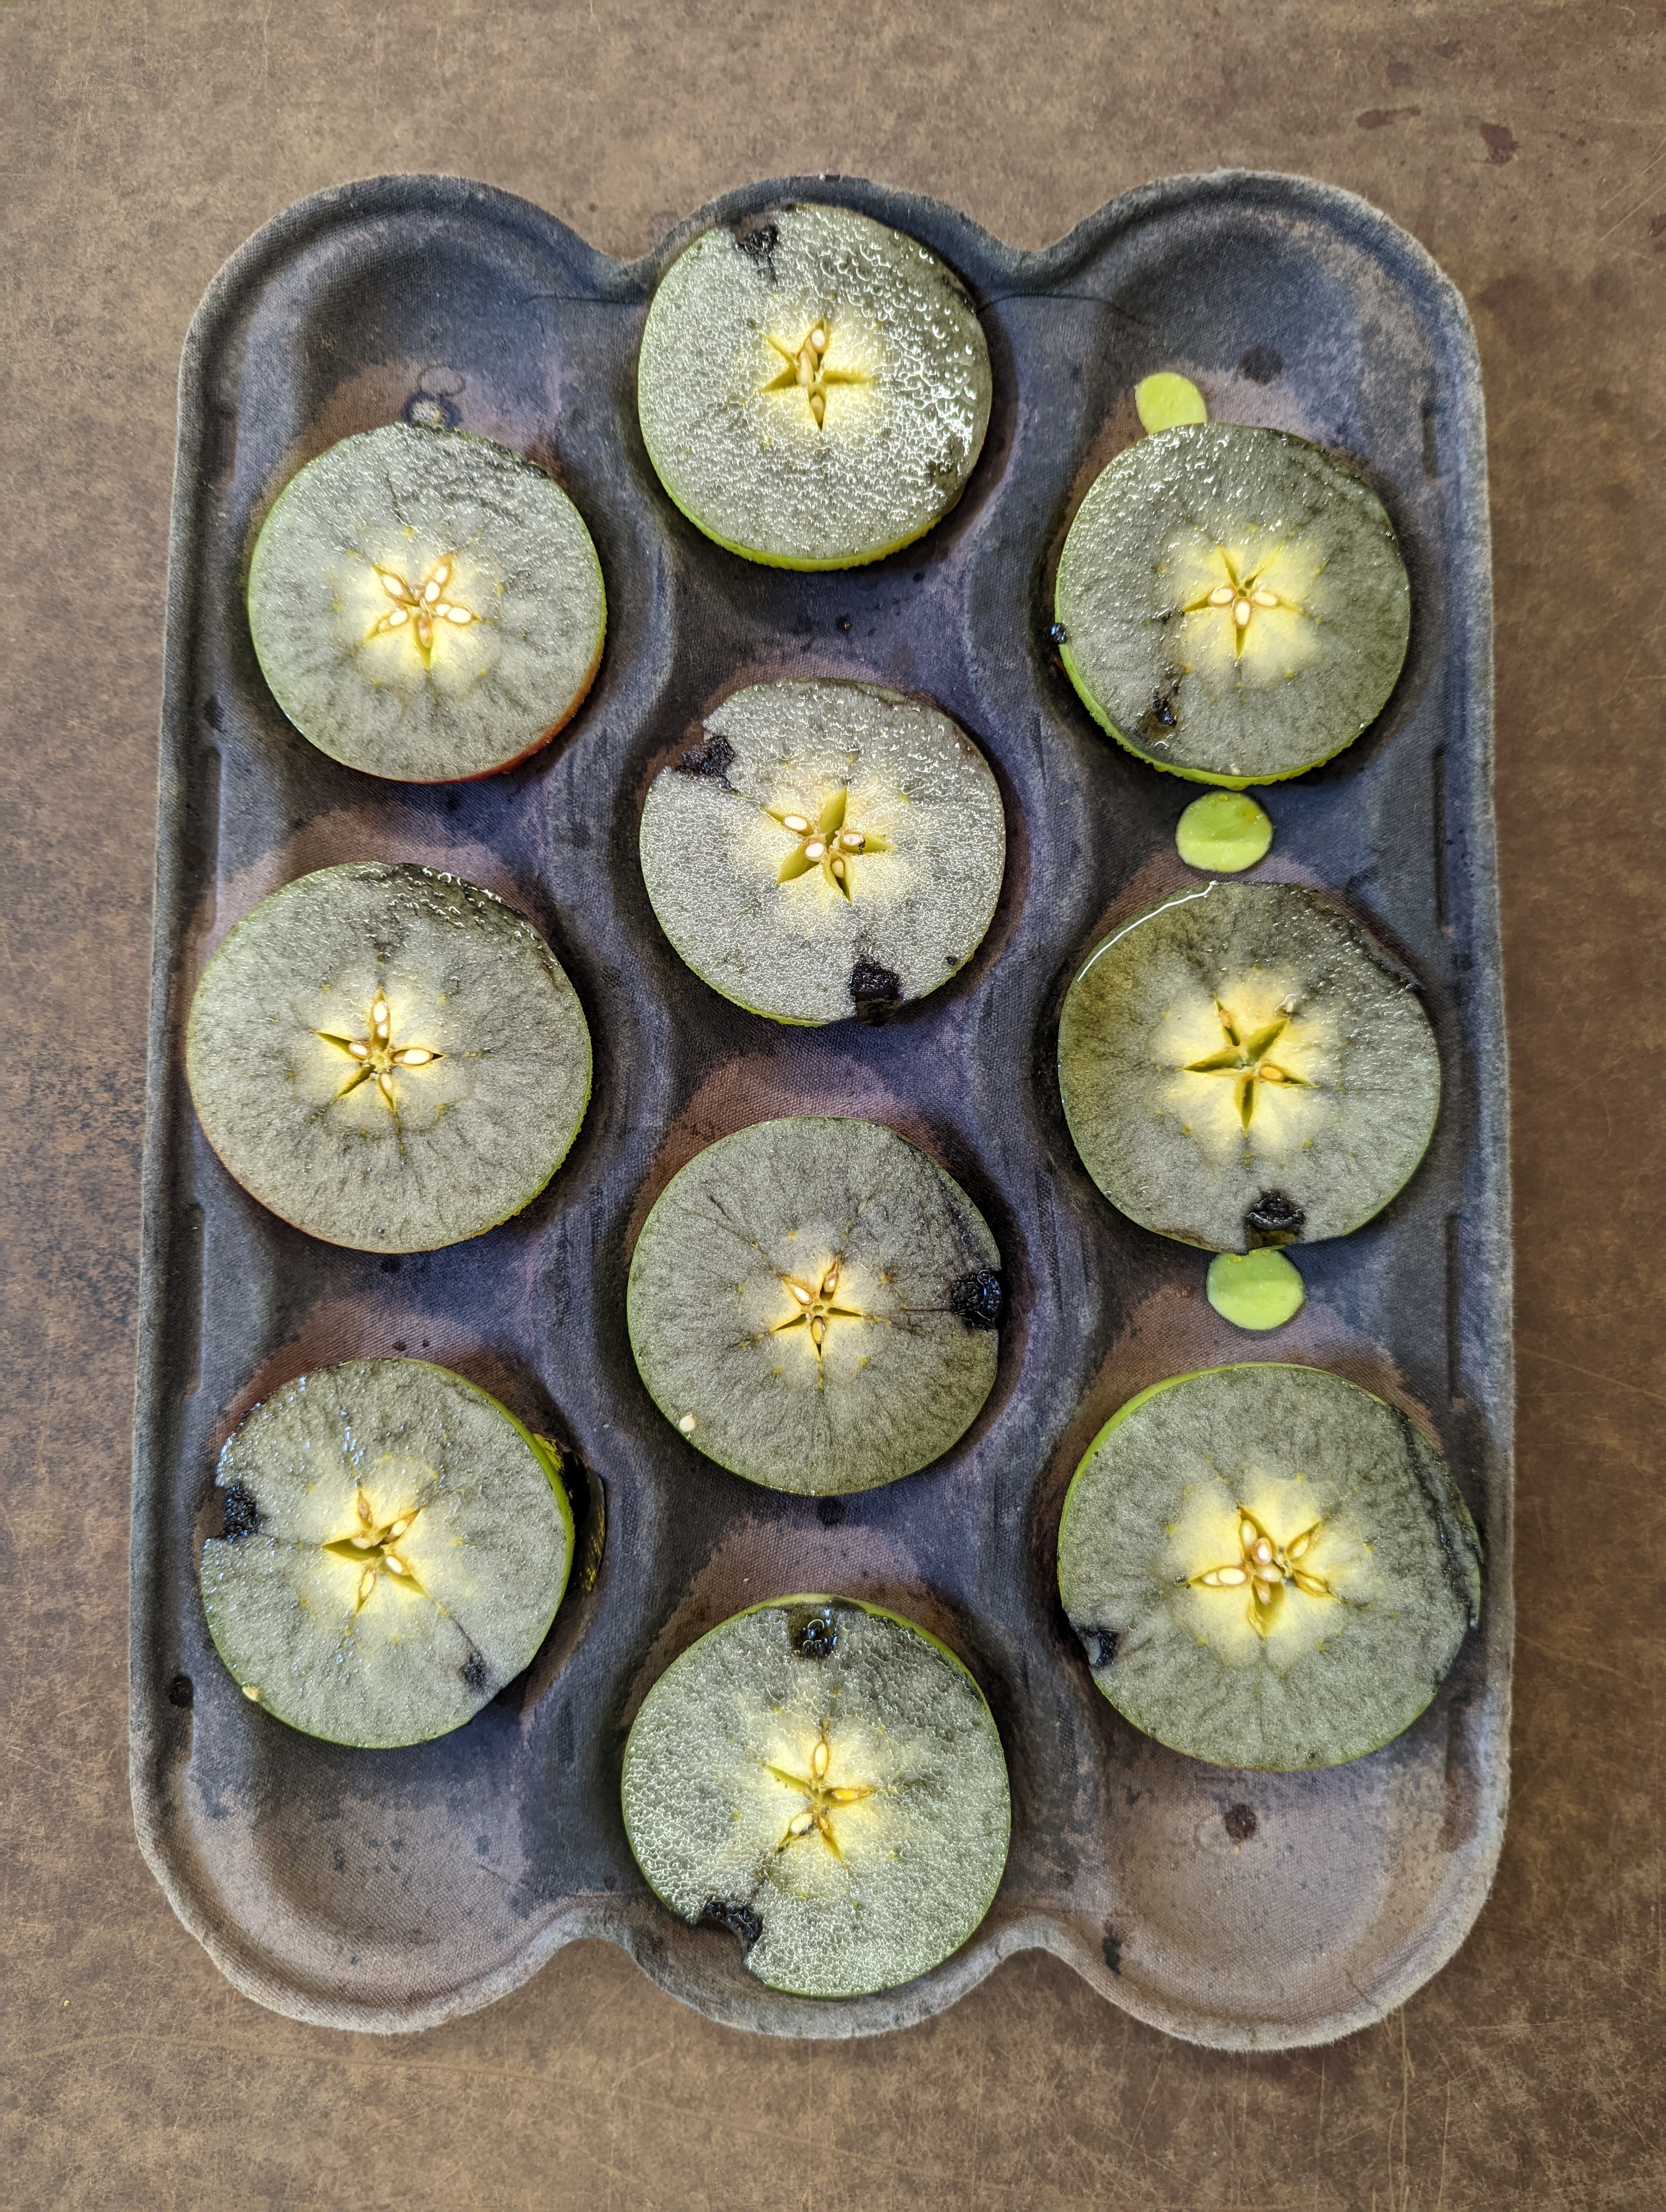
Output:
626 1115 1002 1497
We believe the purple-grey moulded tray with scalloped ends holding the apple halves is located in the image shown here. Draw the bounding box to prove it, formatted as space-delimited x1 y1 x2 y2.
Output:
133 172 1511 2048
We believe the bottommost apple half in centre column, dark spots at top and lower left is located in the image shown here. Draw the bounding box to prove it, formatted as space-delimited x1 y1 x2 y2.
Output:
621 1597 1011 1997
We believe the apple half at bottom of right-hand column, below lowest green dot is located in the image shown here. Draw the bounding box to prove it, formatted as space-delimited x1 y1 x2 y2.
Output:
1058 1365 1480 1772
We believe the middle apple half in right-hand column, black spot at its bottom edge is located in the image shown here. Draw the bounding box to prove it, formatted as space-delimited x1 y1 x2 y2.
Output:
1058 883 1440 1252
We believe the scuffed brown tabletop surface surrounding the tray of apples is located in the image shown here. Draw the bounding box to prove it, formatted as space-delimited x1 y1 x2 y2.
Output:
0 0 1666 2212
